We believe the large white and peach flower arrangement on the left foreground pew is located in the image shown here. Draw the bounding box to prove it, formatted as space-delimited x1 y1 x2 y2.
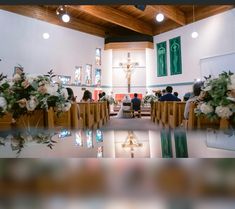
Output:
0 70 71 119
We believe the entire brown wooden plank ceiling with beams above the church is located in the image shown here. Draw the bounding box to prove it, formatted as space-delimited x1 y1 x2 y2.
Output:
0 5 234 37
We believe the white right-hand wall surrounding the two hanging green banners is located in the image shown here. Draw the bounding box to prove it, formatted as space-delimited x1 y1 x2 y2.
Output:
150 9 235 99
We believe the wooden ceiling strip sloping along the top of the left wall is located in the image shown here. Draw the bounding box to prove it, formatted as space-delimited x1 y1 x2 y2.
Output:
0 5 106 37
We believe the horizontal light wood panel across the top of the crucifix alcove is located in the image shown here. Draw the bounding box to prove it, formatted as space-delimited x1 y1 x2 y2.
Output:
104 42 154 50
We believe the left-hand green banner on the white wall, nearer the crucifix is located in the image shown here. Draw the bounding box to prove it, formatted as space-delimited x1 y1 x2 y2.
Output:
157 41 167 77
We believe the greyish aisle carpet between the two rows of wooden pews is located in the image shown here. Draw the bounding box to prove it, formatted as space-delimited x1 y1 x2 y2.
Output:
102 117 160 130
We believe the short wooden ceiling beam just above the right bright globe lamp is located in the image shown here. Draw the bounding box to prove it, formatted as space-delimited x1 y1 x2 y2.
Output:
149 5 186 25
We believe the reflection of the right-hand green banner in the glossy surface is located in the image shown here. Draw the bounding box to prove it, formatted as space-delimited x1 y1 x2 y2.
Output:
174 129 188 158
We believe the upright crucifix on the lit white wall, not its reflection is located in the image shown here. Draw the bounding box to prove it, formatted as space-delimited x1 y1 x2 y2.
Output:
119 52 138 93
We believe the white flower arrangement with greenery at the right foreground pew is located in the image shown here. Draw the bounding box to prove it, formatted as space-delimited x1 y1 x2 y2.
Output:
195 71 235 120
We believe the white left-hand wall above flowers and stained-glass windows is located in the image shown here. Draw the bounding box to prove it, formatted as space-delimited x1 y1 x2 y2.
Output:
0 10 105 98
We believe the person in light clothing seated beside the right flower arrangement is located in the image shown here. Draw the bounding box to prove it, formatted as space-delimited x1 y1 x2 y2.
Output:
184 82 203 119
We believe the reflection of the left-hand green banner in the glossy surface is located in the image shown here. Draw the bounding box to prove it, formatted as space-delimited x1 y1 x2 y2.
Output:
161 129 173 158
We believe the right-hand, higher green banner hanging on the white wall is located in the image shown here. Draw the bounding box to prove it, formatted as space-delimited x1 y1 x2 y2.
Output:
170 36 182 75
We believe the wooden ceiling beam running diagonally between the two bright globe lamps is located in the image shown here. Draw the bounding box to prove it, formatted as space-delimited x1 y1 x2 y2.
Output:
71 5 153 36
